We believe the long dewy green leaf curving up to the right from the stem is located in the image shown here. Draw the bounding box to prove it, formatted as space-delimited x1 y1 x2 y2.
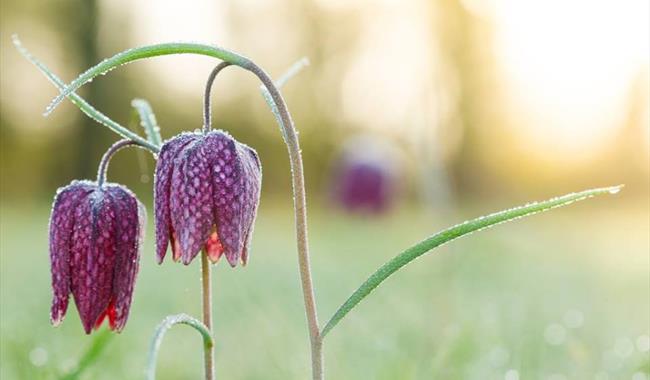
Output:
322 186 622 337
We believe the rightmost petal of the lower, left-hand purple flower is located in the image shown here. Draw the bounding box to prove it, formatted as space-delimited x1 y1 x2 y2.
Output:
107 185 146 332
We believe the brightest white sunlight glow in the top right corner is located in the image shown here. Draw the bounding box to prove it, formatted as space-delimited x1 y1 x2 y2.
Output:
494 0 650 155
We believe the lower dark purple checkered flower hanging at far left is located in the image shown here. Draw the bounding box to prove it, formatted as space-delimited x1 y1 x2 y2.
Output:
50 181 145 334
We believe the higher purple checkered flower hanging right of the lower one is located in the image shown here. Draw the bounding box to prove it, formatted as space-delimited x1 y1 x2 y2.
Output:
154 131 262 267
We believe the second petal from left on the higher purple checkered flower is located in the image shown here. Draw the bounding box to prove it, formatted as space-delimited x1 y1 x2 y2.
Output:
170 138 214 265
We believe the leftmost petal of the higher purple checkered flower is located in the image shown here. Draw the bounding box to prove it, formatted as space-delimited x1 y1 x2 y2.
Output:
154 133 198 264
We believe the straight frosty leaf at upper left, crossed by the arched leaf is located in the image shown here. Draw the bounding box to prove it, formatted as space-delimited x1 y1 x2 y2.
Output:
11 35 158 152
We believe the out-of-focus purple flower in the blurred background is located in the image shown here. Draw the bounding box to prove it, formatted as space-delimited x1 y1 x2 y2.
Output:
332 136 399 213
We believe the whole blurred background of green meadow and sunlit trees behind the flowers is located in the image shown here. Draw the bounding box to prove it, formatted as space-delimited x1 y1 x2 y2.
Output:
0 0 650 380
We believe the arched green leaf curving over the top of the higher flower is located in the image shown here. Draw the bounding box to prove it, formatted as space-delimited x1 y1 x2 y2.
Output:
44 42 254 116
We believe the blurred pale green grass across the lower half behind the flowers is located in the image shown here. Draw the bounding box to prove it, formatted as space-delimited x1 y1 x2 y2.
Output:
0 197 650 380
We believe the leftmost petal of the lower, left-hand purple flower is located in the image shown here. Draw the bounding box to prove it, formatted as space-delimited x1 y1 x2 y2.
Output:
50 182 91 326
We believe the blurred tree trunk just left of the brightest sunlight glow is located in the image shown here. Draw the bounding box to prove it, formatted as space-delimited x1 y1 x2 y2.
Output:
431 0 504 193
